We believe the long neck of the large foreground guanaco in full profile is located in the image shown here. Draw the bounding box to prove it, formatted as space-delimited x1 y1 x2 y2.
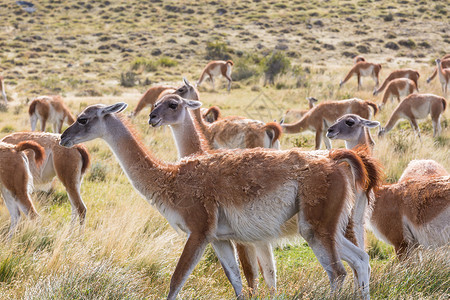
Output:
103 114 176 204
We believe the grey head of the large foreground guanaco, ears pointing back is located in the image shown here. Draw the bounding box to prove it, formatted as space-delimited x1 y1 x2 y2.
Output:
59 102 128 147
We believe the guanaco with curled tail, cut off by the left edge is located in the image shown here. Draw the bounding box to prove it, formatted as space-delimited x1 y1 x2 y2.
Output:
0 141 45 237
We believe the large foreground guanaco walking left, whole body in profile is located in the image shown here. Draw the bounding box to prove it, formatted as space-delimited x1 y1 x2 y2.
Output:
60 103 376 299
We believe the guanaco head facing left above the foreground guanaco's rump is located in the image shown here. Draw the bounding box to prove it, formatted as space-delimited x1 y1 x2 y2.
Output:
327 114 380 141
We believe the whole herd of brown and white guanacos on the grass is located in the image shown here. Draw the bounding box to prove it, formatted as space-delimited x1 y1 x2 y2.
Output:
0 55 450 299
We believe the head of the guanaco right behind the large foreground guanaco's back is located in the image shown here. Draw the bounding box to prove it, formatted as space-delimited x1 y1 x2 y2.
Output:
148 94 202 127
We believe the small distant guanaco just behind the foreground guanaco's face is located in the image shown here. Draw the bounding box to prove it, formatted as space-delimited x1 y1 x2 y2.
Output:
28 96 75 133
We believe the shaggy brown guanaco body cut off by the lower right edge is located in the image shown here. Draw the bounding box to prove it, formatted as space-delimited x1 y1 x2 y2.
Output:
369 176 450 259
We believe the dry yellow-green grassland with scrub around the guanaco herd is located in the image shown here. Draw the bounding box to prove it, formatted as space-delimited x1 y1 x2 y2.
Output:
0 0 450 299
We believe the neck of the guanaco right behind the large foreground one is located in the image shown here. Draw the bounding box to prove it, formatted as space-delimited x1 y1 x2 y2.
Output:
170 112 205 159
